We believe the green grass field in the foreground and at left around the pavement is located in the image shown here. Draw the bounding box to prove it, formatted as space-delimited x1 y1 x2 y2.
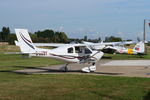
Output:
0 47 150 100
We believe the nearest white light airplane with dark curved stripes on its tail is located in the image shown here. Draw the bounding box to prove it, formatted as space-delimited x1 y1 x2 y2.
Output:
15 29 104 72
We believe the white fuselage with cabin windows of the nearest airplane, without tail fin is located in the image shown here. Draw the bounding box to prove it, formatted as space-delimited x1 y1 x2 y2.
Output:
30 44 103 63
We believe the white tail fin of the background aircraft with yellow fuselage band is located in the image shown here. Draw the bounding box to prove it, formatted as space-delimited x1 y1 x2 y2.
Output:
133 41 145 54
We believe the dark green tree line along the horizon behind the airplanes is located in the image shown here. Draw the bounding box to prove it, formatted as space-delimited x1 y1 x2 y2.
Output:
0 27 122 44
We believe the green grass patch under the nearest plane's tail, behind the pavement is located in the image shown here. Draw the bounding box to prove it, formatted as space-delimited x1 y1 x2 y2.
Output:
0 53 63 70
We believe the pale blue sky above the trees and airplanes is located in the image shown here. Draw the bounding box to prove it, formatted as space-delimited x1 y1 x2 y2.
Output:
0 0 150 40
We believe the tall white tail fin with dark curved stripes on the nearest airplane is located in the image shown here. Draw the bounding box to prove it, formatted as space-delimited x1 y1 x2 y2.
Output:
15 29 36 53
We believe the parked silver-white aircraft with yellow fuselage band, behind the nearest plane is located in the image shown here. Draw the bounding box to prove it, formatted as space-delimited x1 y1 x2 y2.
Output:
83 41 145 55
